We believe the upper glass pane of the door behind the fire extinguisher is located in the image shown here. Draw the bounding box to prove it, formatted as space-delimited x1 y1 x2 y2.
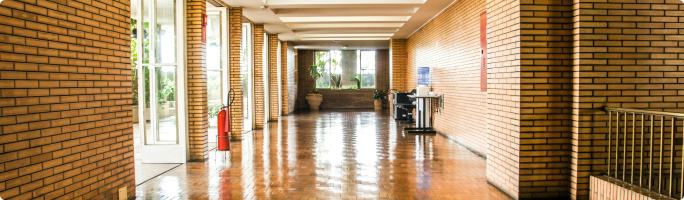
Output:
207 14 221 69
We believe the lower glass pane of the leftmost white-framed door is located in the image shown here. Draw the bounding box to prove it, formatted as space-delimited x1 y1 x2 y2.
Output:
143 66 178 144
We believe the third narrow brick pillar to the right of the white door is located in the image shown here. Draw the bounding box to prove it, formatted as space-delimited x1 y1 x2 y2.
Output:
254 24 265 129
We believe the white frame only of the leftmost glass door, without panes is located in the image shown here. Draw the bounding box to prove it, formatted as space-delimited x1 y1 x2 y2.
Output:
136 0 189 163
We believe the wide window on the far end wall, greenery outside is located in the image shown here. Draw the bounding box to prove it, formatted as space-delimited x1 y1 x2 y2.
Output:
313 50 375 89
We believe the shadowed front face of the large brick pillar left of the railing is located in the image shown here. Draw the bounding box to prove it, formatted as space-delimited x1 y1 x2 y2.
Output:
520 0 572 199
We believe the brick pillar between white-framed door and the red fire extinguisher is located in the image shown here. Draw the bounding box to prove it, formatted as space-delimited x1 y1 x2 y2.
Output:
186 0 209 161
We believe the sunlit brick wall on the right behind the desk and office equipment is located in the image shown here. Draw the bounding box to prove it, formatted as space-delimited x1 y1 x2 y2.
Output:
405 1 487 155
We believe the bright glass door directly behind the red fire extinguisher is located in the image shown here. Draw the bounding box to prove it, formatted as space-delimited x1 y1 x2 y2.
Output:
205 7 228 146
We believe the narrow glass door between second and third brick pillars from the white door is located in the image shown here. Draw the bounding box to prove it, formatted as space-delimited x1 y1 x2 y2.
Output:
240 23 254 133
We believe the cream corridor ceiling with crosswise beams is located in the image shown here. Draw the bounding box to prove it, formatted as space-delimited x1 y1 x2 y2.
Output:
223 0 454 49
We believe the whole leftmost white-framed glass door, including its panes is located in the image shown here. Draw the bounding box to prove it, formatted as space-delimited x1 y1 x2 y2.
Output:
136 0 187 163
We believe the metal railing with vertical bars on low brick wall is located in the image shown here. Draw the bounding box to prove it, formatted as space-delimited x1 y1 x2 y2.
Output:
604 107 684 199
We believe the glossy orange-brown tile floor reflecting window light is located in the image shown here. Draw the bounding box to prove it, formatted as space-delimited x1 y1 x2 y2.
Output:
137 110 509 199
